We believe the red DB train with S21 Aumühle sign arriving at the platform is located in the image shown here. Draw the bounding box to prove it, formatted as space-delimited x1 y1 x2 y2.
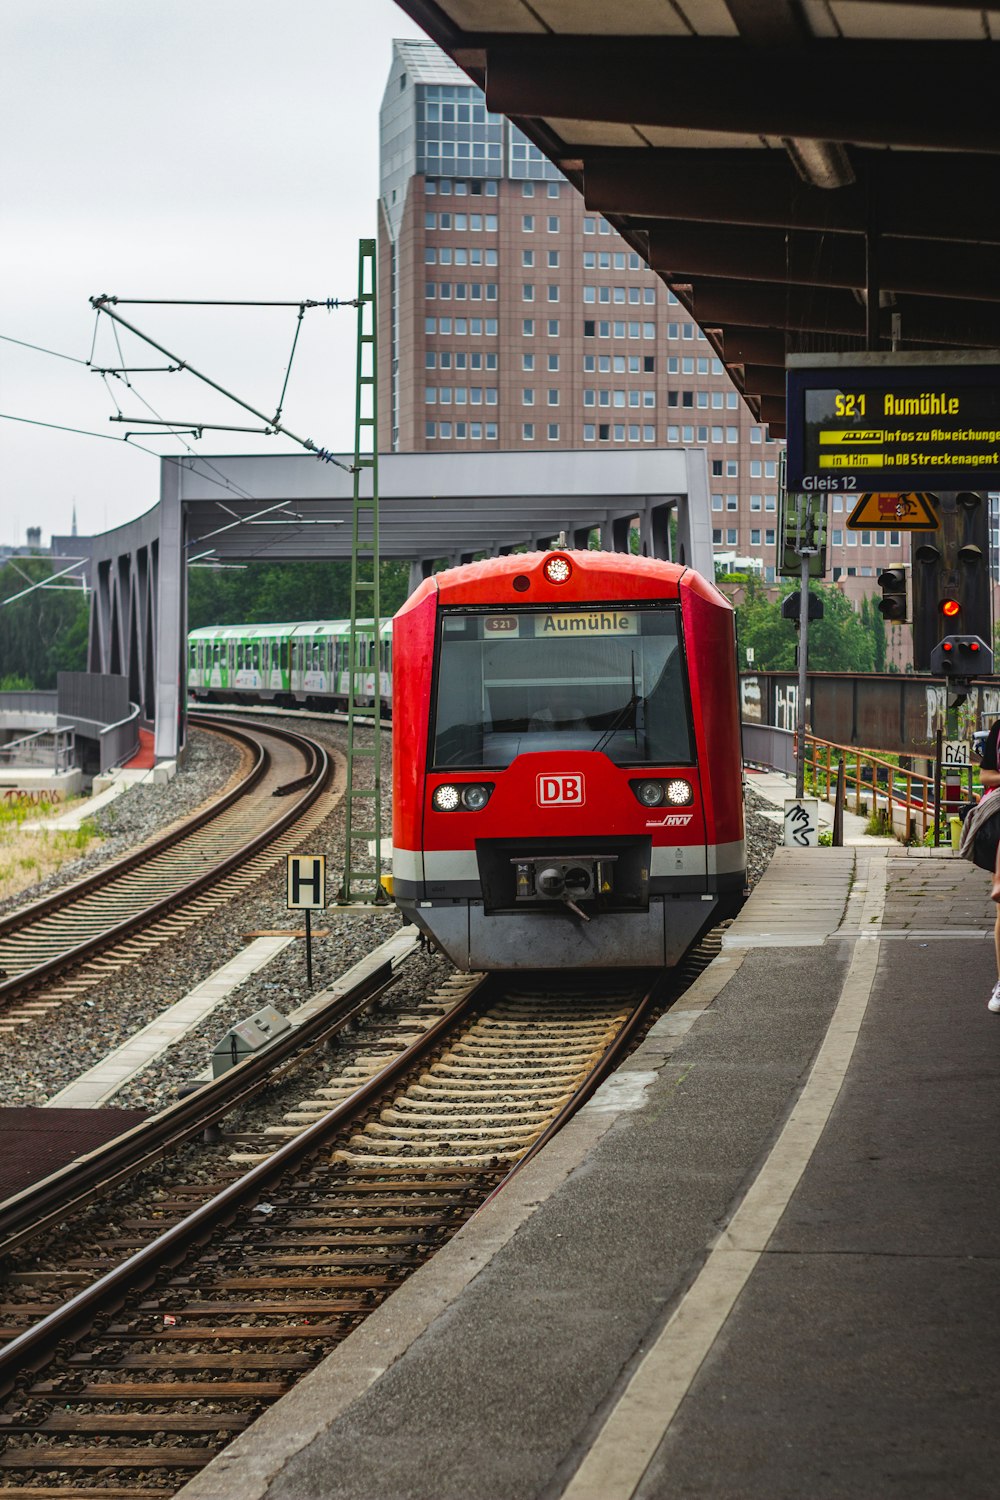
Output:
393 552 747 969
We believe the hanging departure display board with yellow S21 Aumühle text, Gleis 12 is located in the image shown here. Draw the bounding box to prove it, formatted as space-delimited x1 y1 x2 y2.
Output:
787 353 1000 500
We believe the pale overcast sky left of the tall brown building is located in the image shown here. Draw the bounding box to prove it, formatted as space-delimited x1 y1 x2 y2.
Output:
0 0 423 543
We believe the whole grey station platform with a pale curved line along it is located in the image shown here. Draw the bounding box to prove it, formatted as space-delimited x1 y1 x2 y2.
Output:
180 843 1000 1500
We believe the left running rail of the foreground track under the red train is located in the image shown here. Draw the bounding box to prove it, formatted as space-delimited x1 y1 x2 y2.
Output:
0 977 496 1395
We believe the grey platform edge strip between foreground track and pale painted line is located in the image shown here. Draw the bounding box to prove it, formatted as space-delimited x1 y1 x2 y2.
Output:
173 849 858 1500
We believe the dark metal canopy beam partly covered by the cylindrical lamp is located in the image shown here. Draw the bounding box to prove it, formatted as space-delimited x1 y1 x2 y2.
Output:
583 147 1000 245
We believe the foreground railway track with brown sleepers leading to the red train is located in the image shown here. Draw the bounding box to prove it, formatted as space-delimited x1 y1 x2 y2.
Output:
0 956 683 1500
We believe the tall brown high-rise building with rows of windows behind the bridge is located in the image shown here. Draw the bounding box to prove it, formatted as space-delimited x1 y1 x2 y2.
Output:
379 41 901 594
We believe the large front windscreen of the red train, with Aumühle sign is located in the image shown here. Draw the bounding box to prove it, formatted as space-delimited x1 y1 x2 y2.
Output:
432 605 693 768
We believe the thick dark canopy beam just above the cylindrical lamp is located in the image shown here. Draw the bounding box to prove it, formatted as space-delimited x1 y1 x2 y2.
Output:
488 35 1000 152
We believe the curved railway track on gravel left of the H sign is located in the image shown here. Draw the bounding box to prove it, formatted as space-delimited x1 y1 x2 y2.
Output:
0 716 338 1029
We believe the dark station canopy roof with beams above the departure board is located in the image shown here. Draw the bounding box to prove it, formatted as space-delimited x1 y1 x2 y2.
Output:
397 0 1000 437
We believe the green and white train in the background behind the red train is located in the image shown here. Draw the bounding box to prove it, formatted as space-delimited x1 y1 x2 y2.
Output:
187 620 393 708
